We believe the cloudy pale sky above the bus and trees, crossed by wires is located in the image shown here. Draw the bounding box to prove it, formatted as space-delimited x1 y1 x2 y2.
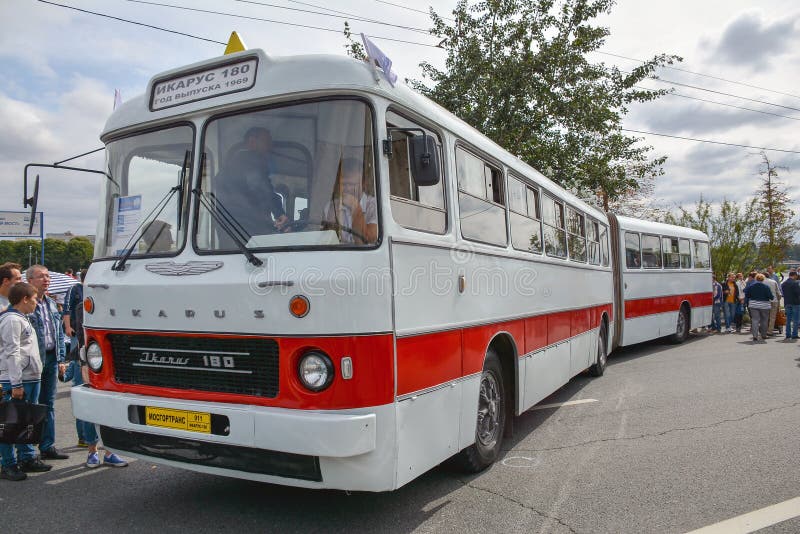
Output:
0 0 800 238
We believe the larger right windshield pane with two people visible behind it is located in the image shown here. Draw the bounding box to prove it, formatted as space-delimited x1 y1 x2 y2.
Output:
196 99 378 251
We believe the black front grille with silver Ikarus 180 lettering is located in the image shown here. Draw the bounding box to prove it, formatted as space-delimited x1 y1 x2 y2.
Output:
108 334 279 398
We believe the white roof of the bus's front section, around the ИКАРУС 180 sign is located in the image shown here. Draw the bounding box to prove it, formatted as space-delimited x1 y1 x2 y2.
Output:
101 49 605 220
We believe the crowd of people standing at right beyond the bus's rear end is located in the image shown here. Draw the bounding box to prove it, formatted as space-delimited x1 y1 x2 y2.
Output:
709 265 800 343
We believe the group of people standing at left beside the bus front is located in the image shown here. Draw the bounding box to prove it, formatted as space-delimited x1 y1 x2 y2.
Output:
0 263 128 481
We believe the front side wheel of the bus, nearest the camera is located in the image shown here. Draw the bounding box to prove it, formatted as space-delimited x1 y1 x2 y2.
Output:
458 349 506 473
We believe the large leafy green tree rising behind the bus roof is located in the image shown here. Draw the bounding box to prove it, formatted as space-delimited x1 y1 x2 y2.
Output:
400 0 680 209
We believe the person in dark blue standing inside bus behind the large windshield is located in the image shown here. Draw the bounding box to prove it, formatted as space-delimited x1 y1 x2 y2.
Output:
216 127 289 236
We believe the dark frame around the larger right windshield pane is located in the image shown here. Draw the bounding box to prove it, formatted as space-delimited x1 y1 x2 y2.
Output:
191 93 385 256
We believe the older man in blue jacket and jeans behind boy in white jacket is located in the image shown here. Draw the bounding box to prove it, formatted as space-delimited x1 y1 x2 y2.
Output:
26 265 69 460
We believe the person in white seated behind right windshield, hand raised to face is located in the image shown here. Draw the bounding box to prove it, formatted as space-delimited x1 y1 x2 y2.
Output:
322 158 378 245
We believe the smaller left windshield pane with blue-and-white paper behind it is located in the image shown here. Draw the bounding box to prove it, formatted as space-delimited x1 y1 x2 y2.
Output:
95 125 194 257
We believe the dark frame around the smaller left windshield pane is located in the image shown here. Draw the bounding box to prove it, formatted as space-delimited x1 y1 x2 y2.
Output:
92 119 197 261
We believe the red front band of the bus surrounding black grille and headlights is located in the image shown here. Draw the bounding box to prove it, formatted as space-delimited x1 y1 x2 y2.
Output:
86 328 394 410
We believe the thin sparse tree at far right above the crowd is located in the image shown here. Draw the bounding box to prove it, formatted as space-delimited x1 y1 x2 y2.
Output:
756 151 797 266
